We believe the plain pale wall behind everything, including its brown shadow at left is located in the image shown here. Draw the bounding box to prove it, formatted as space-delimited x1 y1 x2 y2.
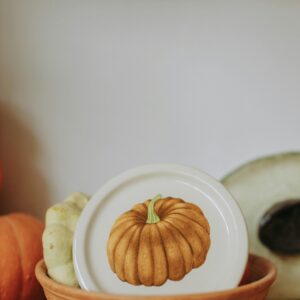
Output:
0 0 300 215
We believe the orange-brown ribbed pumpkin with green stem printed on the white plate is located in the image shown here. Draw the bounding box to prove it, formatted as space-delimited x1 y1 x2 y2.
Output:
107 195 210 286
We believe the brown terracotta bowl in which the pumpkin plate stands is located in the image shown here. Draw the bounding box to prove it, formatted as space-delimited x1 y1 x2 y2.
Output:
35 255 276 300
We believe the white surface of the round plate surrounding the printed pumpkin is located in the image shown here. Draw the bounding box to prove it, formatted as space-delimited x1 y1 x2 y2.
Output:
73 164 248 295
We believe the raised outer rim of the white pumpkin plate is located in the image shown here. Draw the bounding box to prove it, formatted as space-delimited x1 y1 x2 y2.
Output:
72 163 249 296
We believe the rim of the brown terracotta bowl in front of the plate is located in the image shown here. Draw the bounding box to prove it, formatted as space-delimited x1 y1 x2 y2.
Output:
35 254 277 300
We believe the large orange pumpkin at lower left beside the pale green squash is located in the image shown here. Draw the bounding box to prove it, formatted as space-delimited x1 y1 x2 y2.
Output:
0 213 44 300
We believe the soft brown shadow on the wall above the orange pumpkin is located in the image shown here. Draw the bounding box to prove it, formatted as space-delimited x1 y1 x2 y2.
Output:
0 101 49 219
